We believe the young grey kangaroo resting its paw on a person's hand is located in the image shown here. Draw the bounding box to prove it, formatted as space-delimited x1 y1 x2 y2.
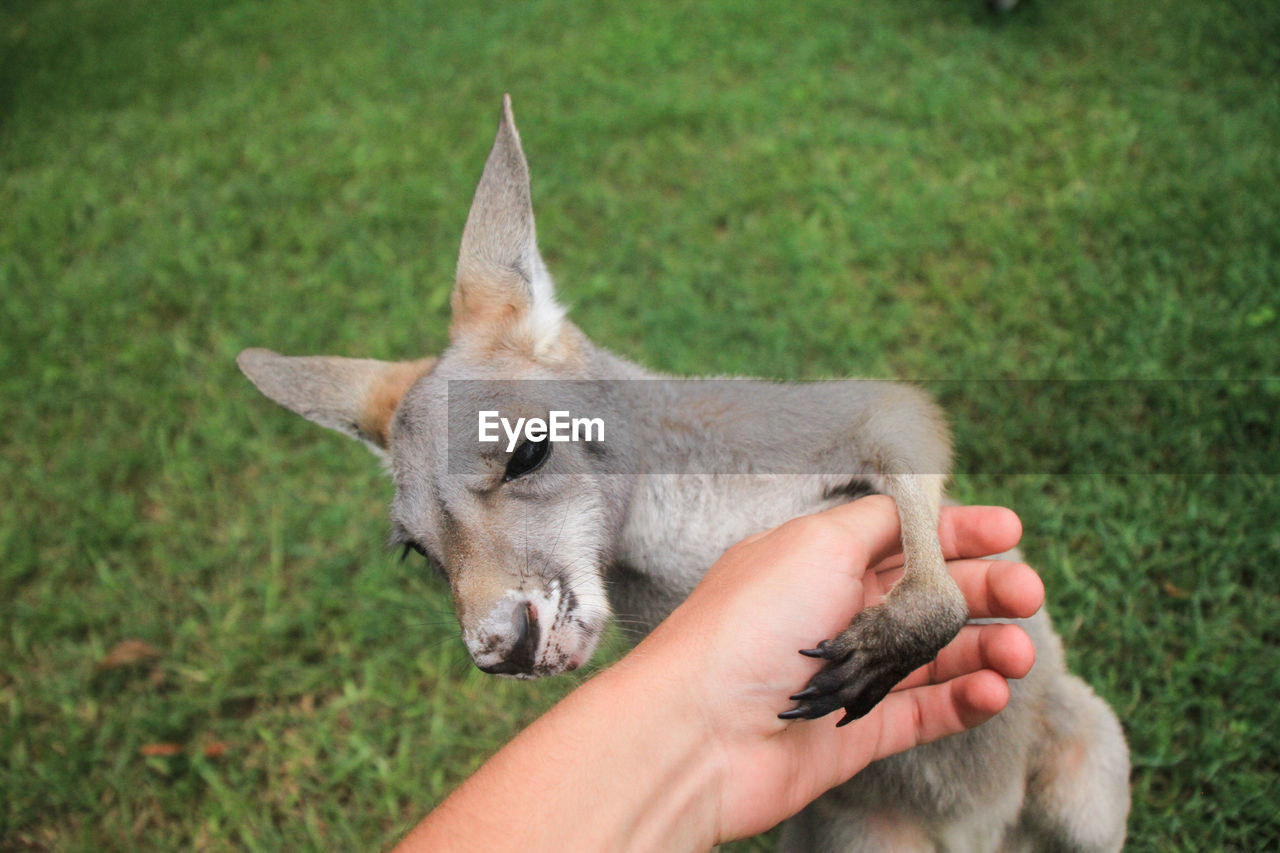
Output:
238 97 1129 853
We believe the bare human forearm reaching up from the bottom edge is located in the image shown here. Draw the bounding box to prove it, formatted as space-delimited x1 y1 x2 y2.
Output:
397 661 718 853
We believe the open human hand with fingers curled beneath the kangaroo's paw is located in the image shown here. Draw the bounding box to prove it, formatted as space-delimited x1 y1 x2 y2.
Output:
620 497 1043 840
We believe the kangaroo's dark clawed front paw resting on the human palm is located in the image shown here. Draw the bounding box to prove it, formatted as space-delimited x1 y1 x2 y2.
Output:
778 602 965 726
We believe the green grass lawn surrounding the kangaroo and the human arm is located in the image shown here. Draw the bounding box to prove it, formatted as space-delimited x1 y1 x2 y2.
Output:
0 0 1280 850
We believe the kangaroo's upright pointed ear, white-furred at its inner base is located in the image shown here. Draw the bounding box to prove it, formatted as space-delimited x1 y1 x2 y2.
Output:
449 95 564 355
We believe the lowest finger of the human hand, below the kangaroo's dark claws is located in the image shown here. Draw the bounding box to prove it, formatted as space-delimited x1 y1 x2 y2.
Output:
873 670 1009 758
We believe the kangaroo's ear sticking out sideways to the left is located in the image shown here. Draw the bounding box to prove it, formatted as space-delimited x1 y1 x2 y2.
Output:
236 350 435 453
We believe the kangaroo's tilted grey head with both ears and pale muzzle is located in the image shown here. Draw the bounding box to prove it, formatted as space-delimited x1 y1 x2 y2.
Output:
237 97 626 678
